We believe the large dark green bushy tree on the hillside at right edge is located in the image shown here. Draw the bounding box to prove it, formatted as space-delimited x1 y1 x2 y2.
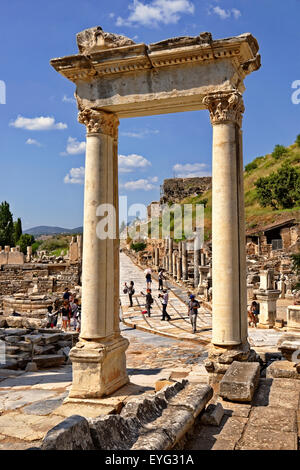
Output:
254 163 300 209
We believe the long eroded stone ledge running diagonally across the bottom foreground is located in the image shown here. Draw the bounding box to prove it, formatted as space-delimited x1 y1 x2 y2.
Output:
41 381 213 450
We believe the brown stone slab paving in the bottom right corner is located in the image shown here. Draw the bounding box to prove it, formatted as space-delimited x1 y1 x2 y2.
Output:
185 379 300 450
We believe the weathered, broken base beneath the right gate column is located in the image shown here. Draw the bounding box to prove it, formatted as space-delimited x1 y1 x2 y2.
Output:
204 341 259 383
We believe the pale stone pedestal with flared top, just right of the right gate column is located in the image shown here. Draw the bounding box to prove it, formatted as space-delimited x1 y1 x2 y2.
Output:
254 289 280 328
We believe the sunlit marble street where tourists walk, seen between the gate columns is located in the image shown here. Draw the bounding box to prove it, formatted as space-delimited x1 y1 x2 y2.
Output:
120 253 211 344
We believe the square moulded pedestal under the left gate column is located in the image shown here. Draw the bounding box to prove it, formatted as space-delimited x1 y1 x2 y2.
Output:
69 336 129 399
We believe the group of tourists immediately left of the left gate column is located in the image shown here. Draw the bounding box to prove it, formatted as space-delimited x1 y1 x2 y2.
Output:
47 287 81 332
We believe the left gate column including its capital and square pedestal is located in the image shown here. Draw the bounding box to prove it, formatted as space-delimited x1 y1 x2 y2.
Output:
69 109 128 399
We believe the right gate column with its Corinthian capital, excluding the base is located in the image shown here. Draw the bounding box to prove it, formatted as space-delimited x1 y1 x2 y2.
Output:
204 90 249 350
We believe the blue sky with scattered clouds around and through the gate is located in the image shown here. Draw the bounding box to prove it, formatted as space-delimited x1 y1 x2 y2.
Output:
0 0 300 228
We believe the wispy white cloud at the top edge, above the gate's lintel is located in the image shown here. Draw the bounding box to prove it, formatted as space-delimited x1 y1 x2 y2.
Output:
116 0 195 26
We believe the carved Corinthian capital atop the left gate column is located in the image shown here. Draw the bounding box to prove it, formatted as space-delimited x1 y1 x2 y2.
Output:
78 109 119 138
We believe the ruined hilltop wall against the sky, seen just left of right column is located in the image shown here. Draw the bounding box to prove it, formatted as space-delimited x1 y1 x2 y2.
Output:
160 176 212 204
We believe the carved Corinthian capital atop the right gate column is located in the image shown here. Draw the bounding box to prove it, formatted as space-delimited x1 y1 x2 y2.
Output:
203 91 245 127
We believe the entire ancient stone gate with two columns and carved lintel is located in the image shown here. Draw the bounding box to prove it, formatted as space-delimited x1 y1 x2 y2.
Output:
51 27 260 399
